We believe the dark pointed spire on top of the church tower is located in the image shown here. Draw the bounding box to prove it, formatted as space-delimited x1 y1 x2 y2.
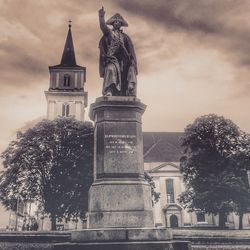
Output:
60 20 76 67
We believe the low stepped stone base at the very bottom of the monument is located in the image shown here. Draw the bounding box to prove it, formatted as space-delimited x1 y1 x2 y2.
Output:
54 228 192 250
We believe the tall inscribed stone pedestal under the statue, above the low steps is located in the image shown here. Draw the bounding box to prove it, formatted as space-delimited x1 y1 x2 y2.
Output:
88 97 154 228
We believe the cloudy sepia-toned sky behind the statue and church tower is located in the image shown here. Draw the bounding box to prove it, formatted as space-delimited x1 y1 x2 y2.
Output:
0 0 250 151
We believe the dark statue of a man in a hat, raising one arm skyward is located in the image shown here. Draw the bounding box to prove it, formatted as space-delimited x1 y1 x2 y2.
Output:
99 7 137 96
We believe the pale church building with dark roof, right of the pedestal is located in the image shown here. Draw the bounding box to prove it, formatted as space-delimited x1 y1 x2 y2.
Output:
143 132 250 229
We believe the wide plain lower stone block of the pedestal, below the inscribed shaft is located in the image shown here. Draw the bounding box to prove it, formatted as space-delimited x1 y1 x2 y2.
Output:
88 180 154 229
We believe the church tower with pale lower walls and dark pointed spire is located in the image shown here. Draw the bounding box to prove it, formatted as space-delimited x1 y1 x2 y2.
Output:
45 21 88 121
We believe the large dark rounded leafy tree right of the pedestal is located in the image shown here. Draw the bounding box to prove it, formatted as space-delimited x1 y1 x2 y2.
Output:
179 114 249 228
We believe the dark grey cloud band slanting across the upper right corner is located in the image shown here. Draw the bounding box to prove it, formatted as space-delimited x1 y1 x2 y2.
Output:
117 0 250 66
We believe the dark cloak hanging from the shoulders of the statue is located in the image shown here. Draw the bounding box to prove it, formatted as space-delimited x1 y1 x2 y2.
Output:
99 33 138 95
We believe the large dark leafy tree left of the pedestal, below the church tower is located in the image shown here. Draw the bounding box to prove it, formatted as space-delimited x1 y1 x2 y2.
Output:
0 118 94 230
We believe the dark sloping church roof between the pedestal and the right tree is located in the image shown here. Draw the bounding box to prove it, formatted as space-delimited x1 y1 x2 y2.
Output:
143 132 184 162
